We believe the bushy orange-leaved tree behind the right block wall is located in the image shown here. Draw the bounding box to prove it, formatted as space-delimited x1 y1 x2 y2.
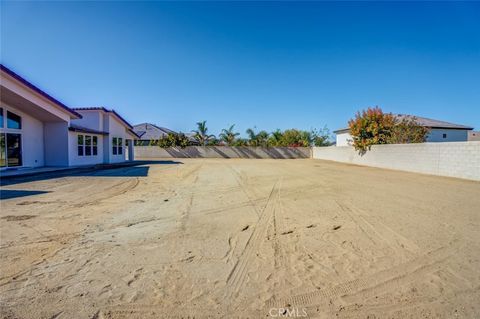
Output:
348 106 395 153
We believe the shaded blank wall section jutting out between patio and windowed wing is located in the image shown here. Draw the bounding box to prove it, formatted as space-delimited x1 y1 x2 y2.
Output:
44 122 70 166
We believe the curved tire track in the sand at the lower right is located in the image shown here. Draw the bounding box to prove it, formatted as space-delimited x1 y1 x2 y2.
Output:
267 242 459 307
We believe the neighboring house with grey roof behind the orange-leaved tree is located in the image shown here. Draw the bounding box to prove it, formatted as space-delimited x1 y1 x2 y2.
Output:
334 114 473 146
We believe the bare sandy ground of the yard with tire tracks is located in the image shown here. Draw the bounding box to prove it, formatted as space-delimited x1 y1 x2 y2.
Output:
0 159 480 319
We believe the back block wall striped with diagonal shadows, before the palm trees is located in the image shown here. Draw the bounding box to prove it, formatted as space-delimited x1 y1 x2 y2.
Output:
135 146 311 159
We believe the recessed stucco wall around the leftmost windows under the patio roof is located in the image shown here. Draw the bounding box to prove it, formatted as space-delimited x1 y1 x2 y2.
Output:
0 102 45 167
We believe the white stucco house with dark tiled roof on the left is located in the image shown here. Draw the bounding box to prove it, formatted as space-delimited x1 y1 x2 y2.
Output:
0 64 137 170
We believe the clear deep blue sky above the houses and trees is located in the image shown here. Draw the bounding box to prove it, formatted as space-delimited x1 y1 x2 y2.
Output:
1 2 480 134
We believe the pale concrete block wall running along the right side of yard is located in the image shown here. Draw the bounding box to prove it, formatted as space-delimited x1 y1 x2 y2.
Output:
312 141 480 180
